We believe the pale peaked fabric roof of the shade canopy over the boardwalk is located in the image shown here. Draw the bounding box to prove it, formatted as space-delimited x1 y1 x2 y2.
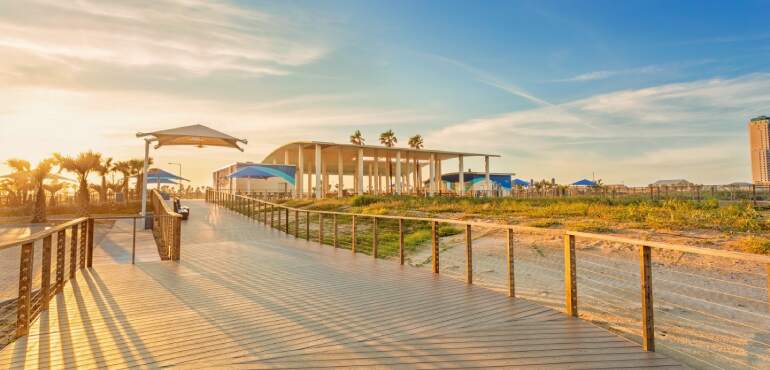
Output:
136 125 248 151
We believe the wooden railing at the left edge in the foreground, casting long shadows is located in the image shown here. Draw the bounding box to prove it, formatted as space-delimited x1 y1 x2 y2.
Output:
0 217 94 338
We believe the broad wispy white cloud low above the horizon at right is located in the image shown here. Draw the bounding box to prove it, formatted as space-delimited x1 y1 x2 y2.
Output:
426 74 770 184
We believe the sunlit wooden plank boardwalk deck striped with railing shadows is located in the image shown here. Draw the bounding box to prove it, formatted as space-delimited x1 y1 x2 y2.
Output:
0 202 680 369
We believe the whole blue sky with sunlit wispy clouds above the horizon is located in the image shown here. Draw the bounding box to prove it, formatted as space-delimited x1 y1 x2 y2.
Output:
0 0 770 185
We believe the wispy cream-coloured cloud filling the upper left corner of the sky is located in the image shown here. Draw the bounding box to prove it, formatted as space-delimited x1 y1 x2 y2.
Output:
0 0 327 83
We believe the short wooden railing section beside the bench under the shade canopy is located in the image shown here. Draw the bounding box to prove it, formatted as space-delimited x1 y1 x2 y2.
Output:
150 189 182 261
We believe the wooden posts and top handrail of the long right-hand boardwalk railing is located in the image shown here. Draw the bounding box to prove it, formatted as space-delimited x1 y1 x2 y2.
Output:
206 190 770 351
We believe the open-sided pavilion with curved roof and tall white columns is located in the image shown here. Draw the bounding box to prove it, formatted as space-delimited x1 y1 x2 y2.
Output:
214 141 499 198
